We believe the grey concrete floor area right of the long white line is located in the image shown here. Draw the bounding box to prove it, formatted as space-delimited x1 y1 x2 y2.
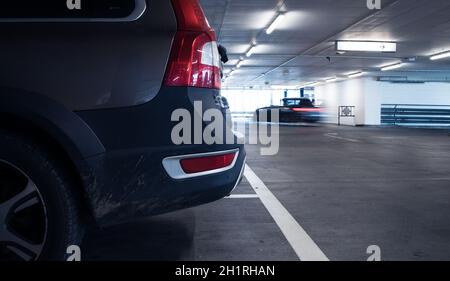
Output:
244 126 450 260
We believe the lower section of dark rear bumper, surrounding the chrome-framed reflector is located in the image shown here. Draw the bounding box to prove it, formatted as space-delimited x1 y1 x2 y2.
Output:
84 142 246 225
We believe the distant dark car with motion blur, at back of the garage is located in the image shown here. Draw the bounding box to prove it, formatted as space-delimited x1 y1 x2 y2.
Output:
255 98 322 123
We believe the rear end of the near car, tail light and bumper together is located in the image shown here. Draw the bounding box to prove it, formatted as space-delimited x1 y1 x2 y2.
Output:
77 0 246 225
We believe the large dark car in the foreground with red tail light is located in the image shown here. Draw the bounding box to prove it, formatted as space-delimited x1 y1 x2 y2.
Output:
0 0 246 260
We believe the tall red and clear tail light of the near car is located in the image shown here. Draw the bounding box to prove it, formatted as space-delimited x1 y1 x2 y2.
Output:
164 0 221 89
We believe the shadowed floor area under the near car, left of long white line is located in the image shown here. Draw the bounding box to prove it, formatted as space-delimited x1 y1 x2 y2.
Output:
83 175 298 261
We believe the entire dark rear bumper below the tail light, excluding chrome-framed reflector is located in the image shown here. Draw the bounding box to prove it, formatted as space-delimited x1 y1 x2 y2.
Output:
78 88 246 226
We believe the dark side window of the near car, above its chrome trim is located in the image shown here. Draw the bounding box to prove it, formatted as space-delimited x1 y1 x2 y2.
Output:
0 0 136 20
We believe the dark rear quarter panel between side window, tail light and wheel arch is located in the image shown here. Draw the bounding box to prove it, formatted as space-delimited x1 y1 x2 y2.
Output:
0 0 177 110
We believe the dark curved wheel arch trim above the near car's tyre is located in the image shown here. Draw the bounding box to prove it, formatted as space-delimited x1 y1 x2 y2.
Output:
0 88 105 222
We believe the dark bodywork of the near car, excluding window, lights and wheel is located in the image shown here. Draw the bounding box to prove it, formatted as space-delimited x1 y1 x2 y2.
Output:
0 0 245 226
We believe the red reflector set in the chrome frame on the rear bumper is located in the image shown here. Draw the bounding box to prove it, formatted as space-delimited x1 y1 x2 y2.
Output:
180 152 236 174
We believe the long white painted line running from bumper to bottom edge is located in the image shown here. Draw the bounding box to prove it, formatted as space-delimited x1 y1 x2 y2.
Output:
244 165 329 261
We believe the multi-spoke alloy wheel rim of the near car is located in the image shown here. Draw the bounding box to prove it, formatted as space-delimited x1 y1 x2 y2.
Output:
0 159 48 261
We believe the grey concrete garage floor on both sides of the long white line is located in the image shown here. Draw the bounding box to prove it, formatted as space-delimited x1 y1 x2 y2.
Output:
83 126 450 261
